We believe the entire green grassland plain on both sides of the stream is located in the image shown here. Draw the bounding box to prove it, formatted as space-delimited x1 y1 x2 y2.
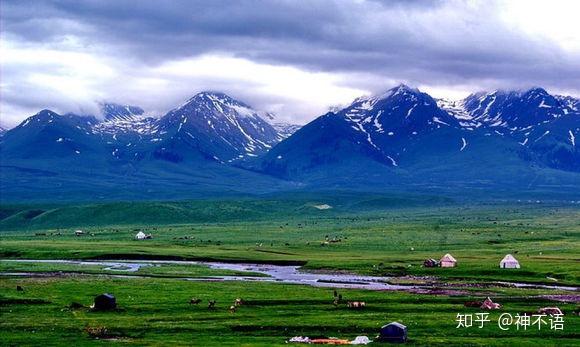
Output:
0 195 580 346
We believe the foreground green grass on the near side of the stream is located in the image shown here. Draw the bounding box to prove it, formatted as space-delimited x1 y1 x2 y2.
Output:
0 277 580 346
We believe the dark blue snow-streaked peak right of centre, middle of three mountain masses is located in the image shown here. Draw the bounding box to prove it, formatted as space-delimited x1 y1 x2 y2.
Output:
263 85 465 175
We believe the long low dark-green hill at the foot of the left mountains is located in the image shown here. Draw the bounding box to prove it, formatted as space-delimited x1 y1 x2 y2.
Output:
0 192 453 230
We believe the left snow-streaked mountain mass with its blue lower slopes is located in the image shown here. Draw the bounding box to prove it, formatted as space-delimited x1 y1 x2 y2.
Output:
0 93 300 201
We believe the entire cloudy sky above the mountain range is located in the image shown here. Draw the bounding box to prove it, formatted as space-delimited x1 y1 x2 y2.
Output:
0 0 580 127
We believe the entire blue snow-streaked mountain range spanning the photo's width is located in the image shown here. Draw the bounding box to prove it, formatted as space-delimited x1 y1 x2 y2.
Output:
0 85 580 201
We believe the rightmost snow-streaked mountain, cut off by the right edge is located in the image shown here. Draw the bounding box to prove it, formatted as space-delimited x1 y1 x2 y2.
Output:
439 88 580 171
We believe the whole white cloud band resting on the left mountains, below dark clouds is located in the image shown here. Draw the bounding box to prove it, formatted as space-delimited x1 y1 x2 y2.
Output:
0 42 366 125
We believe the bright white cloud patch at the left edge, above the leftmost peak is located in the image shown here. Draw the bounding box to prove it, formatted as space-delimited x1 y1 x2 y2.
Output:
0 40 118 125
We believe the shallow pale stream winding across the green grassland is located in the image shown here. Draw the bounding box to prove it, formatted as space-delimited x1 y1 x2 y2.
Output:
0 259 578 291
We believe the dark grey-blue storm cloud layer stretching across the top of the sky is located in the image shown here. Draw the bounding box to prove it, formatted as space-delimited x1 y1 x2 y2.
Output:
1 0 580 125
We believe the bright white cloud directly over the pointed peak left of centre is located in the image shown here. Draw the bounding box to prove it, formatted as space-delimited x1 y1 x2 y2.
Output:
149 55 367 122
